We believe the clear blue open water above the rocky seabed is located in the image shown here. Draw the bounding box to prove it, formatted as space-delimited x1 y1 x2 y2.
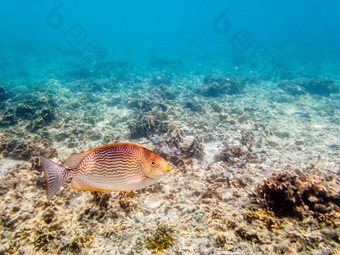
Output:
0 0 340 81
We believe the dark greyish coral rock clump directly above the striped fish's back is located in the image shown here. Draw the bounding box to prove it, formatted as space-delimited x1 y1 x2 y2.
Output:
129 112 171 138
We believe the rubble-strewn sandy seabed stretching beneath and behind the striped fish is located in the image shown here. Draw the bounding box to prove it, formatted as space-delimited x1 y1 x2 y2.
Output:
0 58 340 254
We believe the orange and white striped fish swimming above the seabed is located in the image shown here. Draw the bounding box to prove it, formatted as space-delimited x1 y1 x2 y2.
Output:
40 143 170 199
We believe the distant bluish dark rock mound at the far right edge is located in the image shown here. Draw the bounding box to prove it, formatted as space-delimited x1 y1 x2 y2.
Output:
278 79 339 96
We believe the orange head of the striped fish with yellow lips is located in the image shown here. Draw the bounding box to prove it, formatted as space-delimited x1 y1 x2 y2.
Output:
145 153 170 178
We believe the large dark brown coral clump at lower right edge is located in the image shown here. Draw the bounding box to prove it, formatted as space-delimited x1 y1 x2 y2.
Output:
256 172 340 219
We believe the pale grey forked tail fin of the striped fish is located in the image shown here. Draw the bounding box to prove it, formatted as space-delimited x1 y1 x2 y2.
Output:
40 157 69 199
